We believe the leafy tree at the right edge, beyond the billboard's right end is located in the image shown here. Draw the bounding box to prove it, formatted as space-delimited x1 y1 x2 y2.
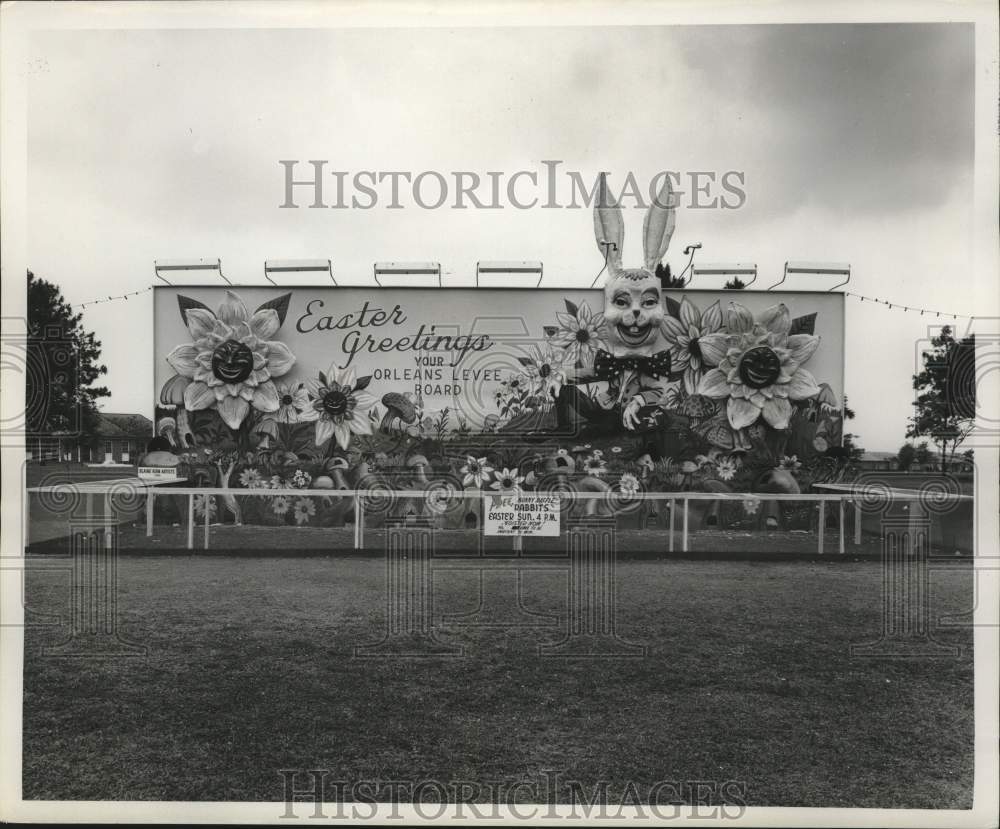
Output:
906 325 975 474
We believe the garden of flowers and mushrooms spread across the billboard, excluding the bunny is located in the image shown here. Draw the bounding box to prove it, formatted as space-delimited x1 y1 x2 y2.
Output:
150 289 842 527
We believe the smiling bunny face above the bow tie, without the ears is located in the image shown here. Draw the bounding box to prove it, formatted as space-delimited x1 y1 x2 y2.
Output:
604 268 663 357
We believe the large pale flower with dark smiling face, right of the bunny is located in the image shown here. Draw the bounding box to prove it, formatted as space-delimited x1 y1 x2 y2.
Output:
698 302 819 429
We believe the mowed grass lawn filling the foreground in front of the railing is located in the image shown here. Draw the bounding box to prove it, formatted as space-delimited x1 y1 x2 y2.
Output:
23 556 974 804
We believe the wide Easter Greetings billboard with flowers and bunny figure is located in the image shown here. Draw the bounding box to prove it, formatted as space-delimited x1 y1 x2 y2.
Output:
153 284 844 488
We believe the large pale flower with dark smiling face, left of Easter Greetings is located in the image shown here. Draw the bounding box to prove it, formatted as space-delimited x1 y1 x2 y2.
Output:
167 291 295 429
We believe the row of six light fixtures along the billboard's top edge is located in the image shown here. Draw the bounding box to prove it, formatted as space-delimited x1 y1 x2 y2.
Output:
154 259 851 291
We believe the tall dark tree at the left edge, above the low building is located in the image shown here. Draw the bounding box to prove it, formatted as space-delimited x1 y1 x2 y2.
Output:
25 271 111 438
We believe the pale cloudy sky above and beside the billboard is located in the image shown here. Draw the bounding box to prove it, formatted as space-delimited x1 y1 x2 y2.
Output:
27 24 977 449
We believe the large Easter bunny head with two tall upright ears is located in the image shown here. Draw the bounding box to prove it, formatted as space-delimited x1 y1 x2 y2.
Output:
594 173 676 357
